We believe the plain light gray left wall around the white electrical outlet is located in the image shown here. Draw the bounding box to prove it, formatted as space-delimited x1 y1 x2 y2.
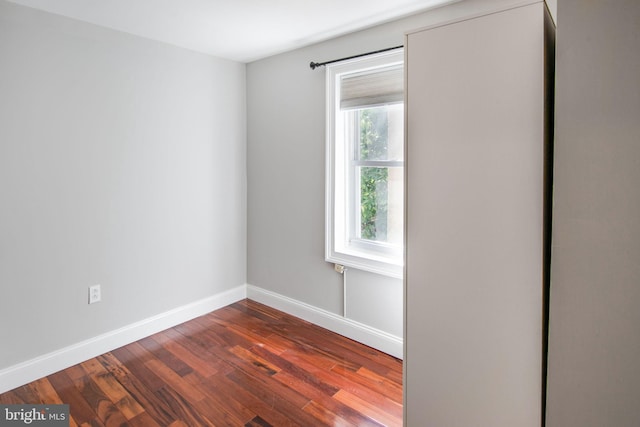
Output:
0 1 246 369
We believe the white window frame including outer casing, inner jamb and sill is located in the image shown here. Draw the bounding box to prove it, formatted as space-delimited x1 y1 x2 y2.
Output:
325 49 404 278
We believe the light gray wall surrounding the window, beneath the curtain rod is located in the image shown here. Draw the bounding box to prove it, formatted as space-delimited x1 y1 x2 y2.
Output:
247 14 411 336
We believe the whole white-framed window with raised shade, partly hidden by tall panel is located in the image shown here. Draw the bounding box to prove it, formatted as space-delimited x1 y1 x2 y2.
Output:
325 50 404 277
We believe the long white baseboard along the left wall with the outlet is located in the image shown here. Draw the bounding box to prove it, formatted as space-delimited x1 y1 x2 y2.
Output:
0 285 247 393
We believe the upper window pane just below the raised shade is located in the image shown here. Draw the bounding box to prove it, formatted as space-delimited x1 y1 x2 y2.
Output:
356 104 404 161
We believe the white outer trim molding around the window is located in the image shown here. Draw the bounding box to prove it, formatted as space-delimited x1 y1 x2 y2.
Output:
325 49 404 278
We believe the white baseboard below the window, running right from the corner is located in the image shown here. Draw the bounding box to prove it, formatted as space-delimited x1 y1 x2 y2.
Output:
247 285 403 359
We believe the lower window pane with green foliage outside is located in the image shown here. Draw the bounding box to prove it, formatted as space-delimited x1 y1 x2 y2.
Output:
358 167 403 245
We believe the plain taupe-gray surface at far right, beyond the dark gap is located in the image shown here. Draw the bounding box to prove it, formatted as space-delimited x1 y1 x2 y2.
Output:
547 0 640 427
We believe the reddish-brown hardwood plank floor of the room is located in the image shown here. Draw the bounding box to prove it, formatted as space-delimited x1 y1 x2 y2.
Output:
0 300 402 427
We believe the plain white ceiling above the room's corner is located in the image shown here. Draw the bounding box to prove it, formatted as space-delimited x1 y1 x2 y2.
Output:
9 0 451 62
